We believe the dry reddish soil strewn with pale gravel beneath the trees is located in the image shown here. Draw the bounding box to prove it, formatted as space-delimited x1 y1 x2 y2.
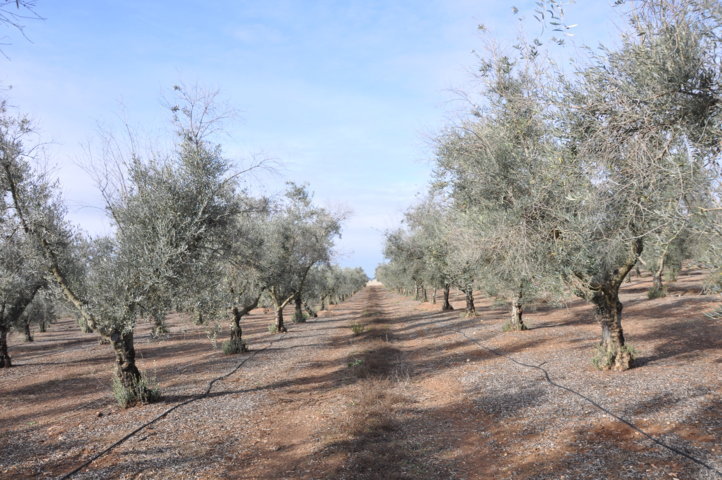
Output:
0 272 722 480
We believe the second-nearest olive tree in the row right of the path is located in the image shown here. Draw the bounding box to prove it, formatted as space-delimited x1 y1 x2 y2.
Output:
430 56 559 330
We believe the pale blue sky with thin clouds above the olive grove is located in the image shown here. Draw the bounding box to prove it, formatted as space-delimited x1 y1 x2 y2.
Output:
0 0 620 277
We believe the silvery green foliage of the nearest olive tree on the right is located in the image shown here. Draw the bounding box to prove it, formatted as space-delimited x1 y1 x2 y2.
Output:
562 1 722 294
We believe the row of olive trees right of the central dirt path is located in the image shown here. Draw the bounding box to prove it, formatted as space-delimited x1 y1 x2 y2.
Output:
379 0 722 370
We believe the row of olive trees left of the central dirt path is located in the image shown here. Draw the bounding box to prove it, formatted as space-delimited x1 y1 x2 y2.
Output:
0 87 358 404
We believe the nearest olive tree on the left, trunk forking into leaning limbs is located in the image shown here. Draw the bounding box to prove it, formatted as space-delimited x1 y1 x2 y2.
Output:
4 89 239 405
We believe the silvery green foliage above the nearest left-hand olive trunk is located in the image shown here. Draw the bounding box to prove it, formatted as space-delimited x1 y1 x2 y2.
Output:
75 90 237 335
